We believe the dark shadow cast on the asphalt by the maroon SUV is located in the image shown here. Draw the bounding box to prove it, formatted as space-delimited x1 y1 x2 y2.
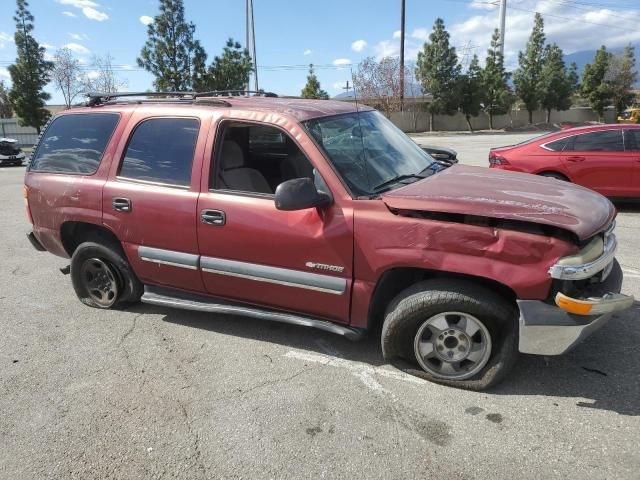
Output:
126 302 640 416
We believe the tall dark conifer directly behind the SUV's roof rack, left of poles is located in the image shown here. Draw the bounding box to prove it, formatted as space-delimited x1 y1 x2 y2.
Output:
137 0 207 91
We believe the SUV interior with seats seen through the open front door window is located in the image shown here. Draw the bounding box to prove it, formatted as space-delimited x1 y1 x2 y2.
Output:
211 122 319 194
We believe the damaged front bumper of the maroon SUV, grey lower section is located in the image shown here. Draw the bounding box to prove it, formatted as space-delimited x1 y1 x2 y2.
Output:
517 260 633 355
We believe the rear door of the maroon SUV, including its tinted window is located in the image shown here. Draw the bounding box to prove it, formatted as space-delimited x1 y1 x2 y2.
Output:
103 112 210 291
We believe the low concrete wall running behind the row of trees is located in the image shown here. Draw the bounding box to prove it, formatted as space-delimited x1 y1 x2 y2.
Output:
391 107 615 132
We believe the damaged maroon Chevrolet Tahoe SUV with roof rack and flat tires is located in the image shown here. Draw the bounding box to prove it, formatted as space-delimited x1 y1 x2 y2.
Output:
25 93 633 389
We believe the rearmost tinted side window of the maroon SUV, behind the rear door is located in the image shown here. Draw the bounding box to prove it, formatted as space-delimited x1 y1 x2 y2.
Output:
29 113 120 175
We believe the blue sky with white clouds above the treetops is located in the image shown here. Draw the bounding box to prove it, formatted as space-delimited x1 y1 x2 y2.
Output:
0 0 640 103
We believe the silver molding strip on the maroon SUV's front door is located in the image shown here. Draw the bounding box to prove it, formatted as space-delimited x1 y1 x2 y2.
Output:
200 257 347 295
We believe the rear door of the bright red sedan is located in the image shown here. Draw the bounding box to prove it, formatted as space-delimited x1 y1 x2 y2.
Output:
562 129 634 197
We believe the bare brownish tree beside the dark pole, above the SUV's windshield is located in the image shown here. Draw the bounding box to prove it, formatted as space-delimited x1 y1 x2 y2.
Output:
354 57 409 117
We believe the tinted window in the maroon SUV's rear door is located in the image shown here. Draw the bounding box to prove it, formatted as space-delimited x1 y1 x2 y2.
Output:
119 118 200 186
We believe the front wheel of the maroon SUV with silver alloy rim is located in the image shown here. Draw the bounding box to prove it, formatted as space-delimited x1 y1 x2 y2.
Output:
382 279 518 391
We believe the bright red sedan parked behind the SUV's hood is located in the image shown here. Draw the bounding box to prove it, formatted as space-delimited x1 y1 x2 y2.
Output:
489 125 640 197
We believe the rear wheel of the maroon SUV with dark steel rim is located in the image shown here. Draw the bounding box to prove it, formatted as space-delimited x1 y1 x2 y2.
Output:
71 242 144 309
